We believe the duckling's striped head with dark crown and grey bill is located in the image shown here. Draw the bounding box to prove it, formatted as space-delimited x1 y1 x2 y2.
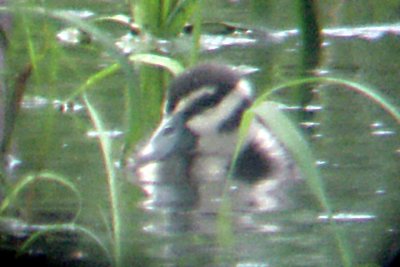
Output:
136 64 252 164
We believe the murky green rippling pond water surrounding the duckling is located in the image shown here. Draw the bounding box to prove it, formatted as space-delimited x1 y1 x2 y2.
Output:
0 0 400 266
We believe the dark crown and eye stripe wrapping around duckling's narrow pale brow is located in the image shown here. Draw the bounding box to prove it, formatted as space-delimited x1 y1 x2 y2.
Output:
166 64 240 116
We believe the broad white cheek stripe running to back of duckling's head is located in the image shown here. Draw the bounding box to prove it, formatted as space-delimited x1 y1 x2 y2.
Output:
187 80 252 134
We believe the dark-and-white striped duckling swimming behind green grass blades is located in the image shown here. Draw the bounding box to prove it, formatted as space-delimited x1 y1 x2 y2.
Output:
134 63 299 216
